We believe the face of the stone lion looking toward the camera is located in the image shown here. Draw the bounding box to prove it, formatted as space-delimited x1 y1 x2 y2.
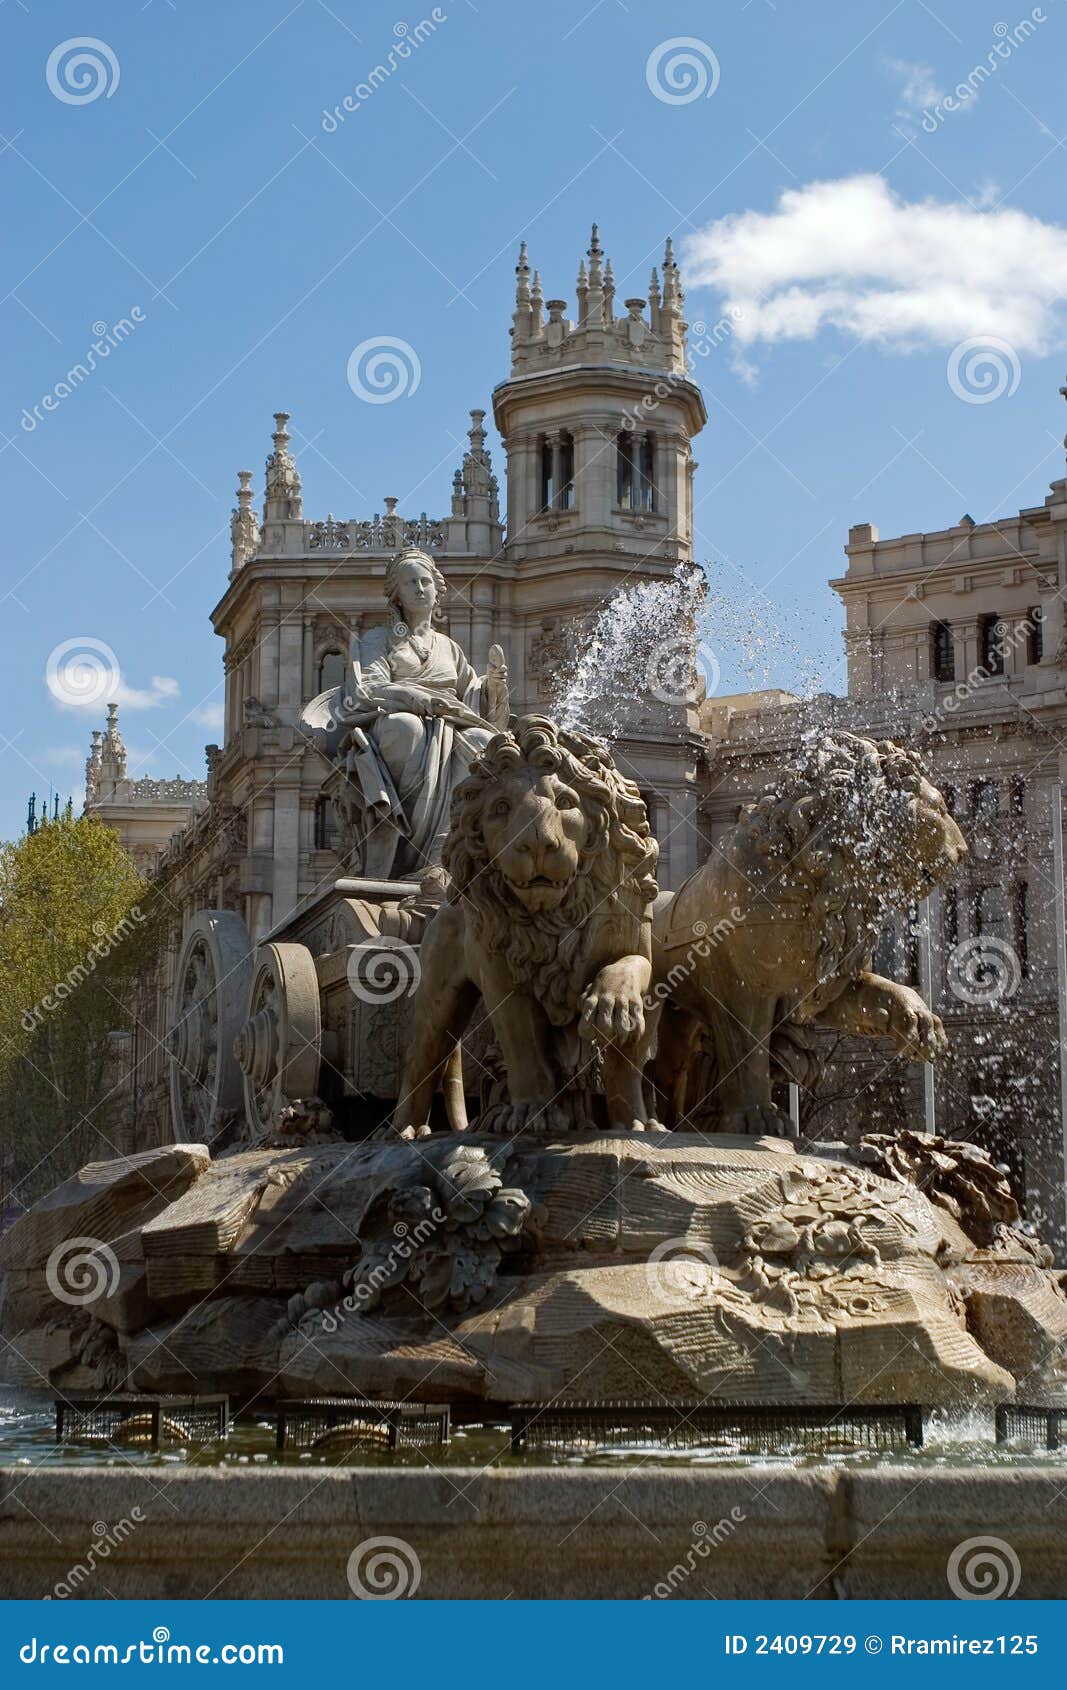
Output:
480 766 588 911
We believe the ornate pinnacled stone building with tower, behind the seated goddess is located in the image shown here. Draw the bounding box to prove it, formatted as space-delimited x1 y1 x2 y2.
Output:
110 226 707 1141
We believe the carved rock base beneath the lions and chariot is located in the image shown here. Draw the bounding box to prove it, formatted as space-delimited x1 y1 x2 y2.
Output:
5 1134 1067 1408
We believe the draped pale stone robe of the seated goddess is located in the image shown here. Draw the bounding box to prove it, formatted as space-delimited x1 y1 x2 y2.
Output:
304 627 507 872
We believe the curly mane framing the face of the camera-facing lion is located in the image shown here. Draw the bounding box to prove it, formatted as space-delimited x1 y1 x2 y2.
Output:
443 717 659 1026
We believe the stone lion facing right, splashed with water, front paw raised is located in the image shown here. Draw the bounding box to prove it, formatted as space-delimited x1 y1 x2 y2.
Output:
649 733 967 1134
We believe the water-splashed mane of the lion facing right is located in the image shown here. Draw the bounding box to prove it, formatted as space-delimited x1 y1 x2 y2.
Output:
739 733 947 985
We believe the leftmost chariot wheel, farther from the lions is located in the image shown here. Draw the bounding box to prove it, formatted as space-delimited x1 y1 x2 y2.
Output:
166 909 252 1144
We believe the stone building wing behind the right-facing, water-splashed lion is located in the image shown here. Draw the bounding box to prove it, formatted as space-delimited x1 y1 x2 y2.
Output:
700 398 1067 1251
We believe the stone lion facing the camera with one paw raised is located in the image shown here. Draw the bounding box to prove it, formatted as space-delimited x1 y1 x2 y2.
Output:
392 717 659 1137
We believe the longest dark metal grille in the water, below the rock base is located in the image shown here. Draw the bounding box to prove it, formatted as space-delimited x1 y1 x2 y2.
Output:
511 1403 923 1455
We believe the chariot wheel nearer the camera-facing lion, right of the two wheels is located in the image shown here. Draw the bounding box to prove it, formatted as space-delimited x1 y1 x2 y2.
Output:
233 945 323 1134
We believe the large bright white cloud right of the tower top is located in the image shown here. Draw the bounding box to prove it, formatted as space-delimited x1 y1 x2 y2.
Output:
683 176 1067 363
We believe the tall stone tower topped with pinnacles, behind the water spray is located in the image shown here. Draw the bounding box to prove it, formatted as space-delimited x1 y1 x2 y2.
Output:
492 223 707 886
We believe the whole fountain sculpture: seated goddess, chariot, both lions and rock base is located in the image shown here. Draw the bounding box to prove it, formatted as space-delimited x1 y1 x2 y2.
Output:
2 577 1067 1411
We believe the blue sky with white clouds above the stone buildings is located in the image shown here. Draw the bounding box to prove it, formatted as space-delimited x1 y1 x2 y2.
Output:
0 0 1067 837
